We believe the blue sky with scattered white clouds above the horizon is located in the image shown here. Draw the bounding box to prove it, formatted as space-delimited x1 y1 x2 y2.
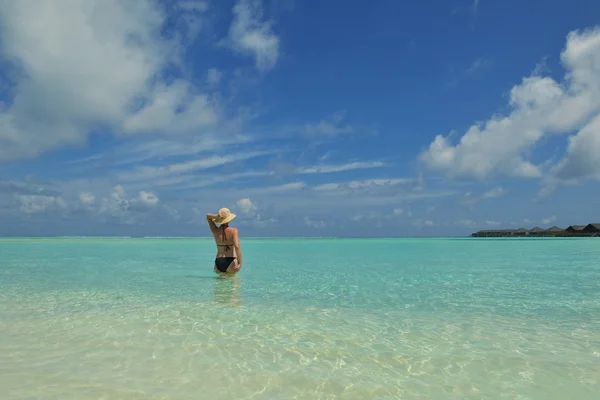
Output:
0 0 600 236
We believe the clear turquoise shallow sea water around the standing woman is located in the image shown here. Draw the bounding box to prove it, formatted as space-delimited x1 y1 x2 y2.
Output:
0 239 600 400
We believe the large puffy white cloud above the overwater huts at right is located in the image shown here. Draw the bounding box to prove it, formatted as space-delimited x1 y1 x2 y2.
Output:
419 28 600 184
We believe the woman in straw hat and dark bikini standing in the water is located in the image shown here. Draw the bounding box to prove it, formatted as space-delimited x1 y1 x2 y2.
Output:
206 208 242 277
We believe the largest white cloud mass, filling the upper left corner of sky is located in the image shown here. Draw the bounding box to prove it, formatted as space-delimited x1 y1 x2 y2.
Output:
0 0 218 161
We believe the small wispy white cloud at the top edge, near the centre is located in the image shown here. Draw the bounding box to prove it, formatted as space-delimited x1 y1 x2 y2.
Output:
225 0 279 71
